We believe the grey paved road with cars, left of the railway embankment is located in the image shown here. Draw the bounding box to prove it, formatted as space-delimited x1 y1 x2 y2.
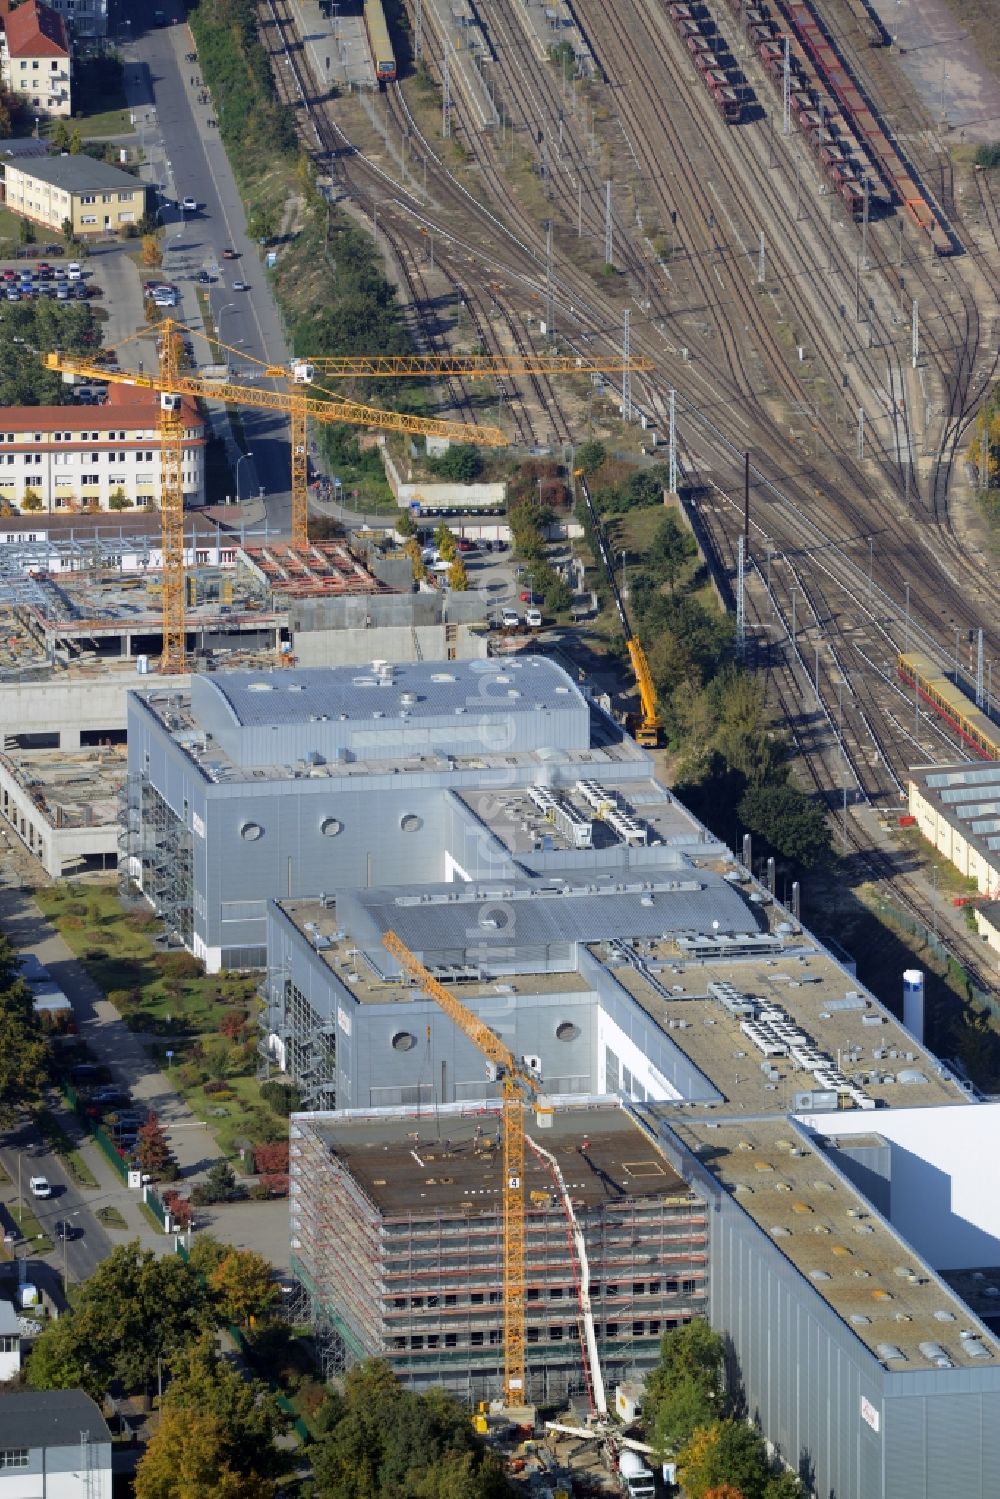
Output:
121 0 291 531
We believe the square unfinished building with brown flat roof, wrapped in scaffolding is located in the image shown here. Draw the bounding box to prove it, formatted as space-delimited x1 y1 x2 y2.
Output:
291 1099 708 1403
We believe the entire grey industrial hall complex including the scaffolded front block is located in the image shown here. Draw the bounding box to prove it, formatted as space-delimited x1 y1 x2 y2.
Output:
124 657 1000 1499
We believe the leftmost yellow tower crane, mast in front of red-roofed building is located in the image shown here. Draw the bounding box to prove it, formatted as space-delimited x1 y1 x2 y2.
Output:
45 331 507 673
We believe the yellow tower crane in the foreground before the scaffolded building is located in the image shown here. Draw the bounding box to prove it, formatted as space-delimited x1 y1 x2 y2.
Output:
382 932 553 1408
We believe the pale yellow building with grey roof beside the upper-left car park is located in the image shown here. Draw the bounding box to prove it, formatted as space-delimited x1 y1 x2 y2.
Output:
3 153 147 238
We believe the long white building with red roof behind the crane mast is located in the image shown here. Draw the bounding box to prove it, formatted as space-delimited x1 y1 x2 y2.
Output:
0 385 205 511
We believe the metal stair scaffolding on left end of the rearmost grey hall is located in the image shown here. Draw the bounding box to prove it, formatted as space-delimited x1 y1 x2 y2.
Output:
118 770 195 947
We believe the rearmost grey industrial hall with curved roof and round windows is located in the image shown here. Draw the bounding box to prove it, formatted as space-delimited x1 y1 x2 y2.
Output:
127 657 683 971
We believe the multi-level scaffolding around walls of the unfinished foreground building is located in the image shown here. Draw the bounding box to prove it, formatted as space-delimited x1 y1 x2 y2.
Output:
289 1105 708 1403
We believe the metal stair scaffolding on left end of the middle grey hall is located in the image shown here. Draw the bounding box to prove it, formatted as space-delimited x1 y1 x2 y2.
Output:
256 968 337 1109
